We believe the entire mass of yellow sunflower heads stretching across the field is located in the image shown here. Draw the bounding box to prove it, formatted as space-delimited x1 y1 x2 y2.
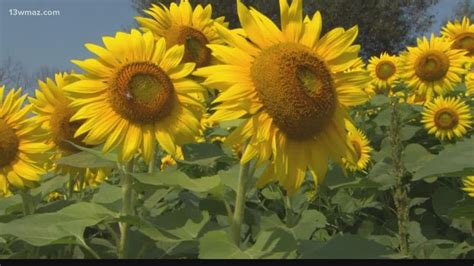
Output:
0 0 474 198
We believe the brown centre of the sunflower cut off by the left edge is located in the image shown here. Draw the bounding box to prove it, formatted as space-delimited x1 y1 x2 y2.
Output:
0 118 20 167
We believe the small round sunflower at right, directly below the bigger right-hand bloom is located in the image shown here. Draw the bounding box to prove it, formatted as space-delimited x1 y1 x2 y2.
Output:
421 96 472 140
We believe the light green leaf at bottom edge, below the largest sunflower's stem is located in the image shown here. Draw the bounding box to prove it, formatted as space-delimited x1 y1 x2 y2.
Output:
199 231 254 259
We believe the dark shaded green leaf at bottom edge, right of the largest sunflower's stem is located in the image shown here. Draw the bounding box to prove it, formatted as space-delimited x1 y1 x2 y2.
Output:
303 235 393 259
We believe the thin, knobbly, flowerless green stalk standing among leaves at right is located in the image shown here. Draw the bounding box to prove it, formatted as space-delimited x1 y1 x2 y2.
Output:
390 97 410 256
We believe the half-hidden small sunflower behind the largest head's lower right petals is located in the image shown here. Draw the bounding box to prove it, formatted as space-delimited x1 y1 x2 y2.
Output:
346 124 373 171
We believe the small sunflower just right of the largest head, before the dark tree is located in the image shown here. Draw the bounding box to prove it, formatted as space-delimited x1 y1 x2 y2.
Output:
367 52 400 91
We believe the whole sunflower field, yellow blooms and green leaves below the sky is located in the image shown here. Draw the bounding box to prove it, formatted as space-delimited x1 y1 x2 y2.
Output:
0 0 474 259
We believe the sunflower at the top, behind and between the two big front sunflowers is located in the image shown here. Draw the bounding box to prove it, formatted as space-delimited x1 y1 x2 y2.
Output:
135 0 227 67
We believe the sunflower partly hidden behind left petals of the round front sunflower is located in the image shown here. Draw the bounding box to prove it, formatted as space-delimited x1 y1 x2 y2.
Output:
29 73 110 186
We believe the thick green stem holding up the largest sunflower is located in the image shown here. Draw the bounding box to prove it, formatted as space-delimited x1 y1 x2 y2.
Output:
231 157 250 246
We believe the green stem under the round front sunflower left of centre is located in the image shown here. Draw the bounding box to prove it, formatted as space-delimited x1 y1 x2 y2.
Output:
117 159 135 259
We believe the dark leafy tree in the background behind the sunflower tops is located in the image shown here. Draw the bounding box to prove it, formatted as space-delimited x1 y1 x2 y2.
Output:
131 0 438 57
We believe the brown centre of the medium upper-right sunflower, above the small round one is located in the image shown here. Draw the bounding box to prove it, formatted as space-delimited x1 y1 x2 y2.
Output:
415 51 449 81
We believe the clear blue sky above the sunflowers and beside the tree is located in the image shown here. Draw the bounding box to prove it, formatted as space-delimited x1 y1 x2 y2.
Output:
0 0 466 79
